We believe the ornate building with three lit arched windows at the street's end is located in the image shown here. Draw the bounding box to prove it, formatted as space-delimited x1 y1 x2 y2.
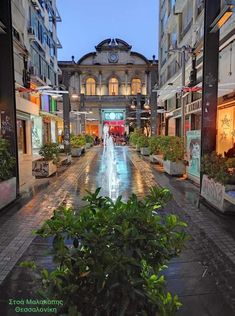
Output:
59 38 157 136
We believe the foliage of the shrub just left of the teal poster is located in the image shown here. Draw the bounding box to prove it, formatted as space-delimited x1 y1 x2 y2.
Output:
159 136 184 162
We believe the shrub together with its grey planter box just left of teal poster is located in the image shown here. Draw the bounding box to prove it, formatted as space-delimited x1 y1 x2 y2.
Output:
160 136 185 176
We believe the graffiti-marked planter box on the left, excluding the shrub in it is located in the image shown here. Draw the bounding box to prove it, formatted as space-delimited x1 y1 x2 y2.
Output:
32 159 57 178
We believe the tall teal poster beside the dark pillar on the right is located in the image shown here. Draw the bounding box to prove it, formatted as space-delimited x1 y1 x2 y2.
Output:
187 131 201 178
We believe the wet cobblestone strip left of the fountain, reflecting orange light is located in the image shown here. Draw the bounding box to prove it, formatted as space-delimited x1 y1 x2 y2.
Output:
0 148 97 284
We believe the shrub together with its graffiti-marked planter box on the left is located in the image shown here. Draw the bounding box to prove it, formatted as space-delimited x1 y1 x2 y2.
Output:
32 143 60 178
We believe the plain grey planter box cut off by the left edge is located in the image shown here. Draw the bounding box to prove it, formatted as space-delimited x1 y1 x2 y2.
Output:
0 178 16 209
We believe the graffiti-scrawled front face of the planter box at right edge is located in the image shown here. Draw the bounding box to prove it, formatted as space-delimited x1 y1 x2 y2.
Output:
201 175 225 210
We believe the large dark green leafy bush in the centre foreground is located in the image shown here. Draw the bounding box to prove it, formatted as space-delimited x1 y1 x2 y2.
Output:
22 188 186 316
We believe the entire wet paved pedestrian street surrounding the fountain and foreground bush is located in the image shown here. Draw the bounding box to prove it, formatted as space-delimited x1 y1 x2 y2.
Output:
0 146 235 316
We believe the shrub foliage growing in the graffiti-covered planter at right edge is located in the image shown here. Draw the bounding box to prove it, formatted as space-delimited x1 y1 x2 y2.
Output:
202 152 235 185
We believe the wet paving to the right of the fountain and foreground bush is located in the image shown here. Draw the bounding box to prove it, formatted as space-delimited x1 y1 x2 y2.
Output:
129 150 235 316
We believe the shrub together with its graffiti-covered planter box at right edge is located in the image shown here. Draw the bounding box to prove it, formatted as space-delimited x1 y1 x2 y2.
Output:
201 152 235 213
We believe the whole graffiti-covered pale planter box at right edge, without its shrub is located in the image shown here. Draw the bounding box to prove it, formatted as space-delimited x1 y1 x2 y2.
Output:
201 175 235 213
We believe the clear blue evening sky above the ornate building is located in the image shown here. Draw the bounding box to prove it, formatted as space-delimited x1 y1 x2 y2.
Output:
57 0 158 60
